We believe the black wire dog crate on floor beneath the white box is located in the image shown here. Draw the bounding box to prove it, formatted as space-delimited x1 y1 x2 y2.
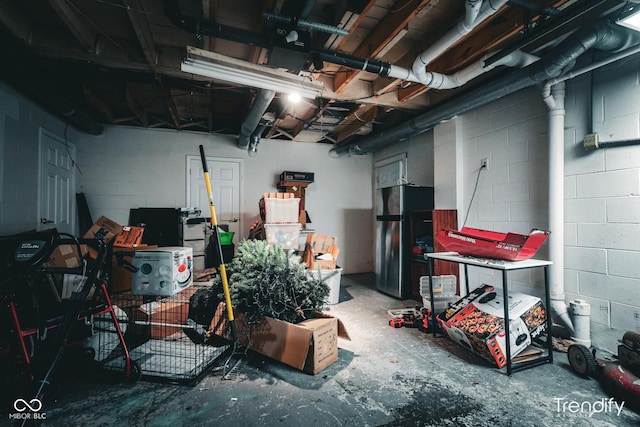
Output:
93 284 229 382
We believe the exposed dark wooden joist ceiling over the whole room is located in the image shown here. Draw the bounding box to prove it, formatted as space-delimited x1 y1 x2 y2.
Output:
0 0 624 147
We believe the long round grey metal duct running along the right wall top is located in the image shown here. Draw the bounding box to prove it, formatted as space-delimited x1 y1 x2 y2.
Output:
329 20 640 157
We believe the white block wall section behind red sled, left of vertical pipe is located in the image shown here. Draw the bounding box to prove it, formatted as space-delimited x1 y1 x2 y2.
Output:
450 89 548 297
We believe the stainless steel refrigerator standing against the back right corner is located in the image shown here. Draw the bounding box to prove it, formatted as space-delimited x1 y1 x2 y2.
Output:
376 185 433 298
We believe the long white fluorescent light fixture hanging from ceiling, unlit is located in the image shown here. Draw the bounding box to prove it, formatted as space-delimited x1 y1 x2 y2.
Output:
180 46 323 98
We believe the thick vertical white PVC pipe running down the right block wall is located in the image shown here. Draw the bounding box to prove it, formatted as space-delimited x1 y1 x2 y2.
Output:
545 82 574 334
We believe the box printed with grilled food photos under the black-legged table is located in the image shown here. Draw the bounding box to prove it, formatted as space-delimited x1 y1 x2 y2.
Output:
438 285 547 368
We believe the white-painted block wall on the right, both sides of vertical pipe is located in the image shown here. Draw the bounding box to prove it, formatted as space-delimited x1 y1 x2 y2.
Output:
434 54 640 352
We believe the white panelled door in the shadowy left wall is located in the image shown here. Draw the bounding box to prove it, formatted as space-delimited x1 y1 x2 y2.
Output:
38 128 76 235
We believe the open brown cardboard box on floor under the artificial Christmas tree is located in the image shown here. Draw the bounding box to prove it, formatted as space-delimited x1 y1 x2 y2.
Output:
211 303 349 374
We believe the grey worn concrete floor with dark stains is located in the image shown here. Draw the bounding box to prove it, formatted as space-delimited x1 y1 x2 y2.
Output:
4 274 640 427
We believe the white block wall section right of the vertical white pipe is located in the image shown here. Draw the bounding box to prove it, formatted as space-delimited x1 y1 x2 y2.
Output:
564 58 640 351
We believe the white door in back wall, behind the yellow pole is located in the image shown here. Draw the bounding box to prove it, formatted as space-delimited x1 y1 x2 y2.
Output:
187 156 242 244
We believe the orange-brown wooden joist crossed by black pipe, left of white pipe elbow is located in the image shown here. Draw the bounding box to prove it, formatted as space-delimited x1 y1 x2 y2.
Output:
333 0 430 92
